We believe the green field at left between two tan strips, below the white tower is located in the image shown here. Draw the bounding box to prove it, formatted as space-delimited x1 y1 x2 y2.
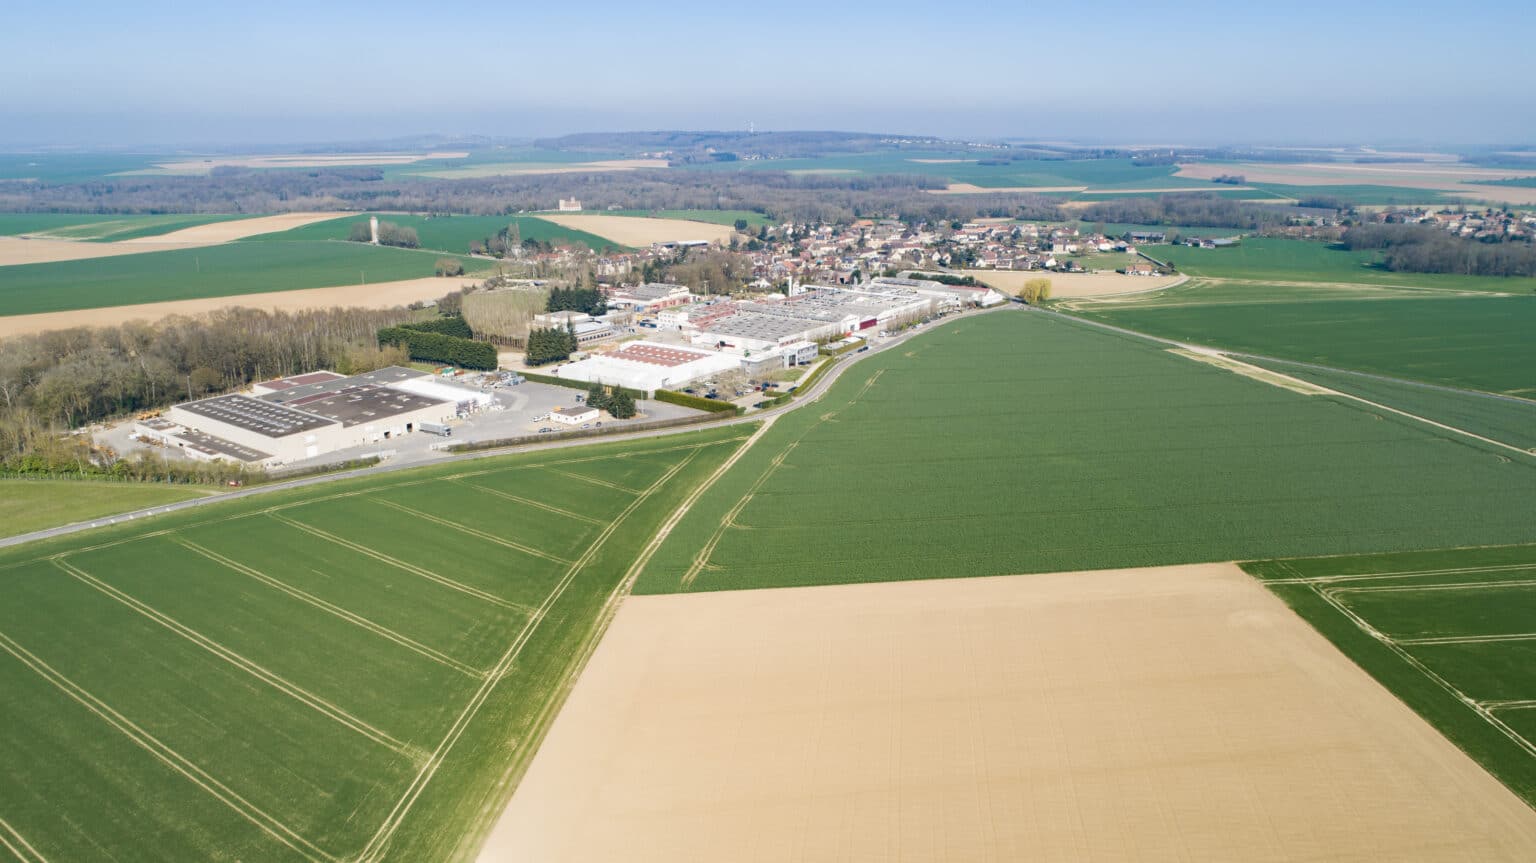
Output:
0 241 488 315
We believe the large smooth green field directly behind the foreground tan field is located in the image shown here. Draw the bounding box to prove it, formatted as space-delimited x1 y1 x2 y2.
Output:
637 310 1536 593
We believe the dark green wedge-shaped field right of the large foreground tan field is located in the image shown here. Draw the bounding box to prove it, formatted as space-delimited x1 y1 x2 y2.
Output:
1243 545 1536 805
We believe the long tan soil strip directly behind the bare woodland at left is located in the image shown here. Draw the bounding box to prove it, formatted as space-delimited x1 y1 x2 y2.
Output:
0 278 479 338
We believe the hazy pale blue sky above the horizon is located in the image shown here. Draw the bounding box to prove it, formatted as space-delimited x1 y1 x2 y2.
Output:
0 0 1536 144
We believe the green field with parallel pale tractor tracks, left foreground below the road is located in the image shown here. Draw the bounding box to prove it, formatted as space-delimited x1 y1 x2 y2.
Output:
0 427 751 861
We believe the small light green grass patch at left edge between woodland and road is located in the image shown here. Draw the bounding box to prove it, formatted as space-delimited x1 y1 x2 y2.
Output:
0 479 209 536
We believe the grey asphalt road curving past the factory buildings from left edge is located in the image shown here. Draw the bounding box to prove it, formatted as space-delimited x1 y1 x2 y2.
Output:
0 304 1015 548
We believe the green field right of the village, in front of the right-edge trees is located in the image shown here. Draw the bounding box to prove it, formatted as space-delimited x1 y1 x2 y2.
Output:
1147 238 1536 293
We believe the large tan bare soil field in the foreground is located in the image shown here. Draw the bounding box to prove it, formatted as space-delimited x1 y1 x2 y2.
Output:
481 564 1536 863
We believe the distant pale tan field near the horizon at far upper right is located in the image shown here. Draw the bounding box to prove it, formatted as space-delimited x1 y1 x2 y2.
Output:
1175 163 1536 204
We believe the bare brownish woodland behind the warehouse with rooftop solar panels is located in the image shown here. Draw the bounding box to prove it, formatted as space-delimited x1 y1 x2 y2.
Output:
0 309 409 473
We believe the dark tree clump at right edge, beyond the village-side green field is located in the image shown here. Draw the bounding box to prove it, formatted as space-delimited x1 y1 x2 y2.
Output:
1342 224 1536 276
